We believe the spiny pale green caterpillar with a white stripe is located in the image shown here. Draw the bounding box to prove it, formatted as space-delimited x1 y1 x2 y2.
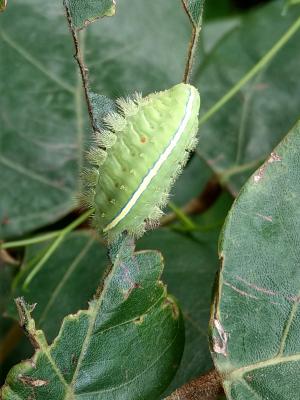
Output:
83 83 200 242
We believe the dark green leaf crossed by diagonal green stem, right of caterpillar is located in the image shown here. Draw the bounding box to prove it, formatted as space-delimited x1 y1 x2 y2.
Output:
195 1 300 194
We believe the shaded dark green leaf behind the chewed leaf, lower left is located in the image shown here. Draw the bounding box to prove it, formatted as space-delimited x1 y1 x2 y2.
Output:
6 231 109 341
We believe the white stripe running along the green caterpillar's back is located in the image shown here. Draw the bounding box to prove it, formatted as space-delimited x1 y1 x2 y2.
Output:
103 90 195 232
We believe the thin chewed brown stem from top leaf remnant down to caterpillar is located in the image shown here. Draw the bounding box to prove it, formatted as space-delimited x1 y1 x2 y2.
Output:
64 3 97 131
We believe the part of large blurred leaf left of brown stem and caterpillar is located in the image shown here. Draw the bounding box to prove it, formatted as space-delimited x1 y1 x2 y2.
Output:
0 0 86 238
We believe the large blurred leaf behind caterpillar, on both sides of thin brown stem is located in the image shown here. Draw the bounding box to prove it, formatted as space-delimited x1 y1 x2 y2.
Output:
0 0 190 238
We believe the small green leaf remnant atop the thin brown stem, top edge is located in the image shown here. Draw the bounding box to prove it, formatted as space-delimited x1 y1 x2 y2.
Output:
64 0 116 29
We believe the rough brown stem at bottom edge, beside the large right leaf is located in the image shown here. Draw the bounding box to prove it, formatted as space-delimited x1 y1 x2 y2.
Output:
165 370 223 400
